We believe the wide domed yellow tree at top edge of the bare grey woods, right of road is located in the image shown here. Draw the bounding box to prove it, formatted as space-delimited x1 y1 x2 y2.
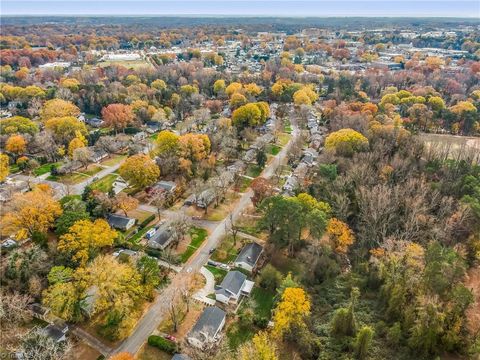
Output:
325 129 368 156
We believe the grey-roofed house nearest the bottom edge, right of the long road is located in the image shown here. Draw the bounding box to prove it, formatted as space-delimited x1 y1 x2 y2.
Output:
187 306 226 349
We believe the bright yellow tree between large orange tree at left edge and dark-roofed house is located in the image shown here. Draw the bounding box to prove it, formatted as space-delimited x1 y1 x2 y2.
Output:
58 219 118 266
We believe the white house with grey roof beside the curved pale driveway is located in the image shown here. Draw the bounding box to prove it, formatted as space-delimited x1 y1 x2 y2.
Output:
215 270 254 304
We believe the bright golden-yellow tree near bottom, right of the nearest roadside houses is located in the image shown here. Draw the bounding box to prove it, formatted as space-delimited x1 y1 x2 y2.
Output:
273 288 310 337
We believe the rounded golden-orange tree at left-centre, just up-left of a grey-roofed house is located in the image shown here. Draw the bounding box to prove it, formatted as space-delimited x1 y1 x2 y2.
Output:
118 154 160 189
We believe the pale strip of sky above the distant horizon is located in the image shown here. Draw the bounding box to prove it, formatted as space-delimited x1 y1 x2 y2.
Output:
0 0 480 19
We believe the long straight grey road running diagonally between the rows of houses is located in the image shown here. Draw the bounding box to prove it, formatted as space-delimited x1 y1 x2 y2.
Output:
114 120 300 354
